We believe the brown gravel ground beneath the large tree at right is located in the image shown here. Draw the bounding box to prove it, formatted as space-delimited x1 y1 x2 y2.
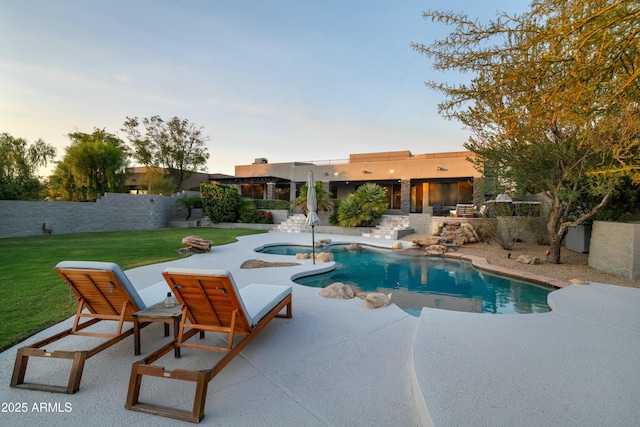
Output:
402 234 640 288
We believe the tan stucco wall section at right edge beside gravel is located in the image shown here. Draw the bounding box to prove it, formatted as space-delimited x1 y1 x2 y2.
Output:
589 221 640 280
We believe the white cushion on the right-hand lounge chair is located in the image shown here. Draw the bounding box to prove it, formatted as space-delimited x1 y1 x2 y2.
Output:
164 268 292 327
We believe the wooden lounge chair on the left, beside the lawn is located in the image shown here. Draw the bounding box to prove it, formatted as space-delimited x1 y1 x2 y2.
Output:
11 261 146 394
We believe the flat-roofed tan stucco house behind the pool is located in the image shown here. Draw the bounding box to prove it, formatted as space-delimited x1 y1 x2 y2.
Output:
211 151 485 215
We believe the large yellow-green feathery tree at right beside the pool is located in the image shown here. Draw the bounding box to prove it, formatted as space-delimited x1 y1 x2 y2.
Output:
413 0 640 263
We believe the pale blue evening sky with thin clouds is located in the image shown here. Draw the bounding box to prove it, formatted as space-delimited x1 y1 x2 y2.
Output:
0 0 529 175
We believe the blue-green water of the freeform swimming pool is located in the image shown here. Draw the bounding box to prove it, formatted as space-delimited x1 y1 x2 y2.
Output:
261 245 554 316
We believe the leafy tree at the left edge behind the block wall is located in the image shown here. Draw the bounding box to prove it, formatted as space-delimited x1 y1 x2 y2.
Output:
0 133 56 200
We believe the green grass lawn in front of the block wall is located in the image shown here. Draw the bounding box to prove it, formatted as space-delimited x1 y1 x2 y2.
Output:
0 228 261 352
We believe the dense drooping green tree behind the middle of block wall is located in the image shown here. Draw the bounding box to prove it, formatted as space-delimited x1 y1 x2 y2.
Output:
52 129 127 200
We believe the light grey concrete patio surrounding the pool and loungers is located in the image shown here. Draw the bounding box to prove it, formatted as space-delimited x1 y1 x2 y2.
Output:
0 233 640 427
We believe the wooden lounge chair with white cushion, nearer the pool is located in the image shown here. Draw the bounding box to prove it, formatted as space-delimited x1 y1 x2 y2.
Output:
125 268 291 423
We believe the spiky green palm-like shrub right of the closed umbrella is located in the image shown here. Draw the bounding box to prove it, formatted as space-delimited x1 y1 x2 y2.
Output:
338 182 387 227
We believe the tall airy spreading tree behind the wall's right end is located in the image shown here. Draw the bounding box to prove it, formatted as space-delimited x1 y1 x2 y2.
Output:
122 116 209 190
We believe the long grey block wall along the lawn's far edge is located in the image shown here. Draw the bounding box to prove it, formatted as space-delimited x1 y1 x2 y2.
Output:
0 193 187 238
